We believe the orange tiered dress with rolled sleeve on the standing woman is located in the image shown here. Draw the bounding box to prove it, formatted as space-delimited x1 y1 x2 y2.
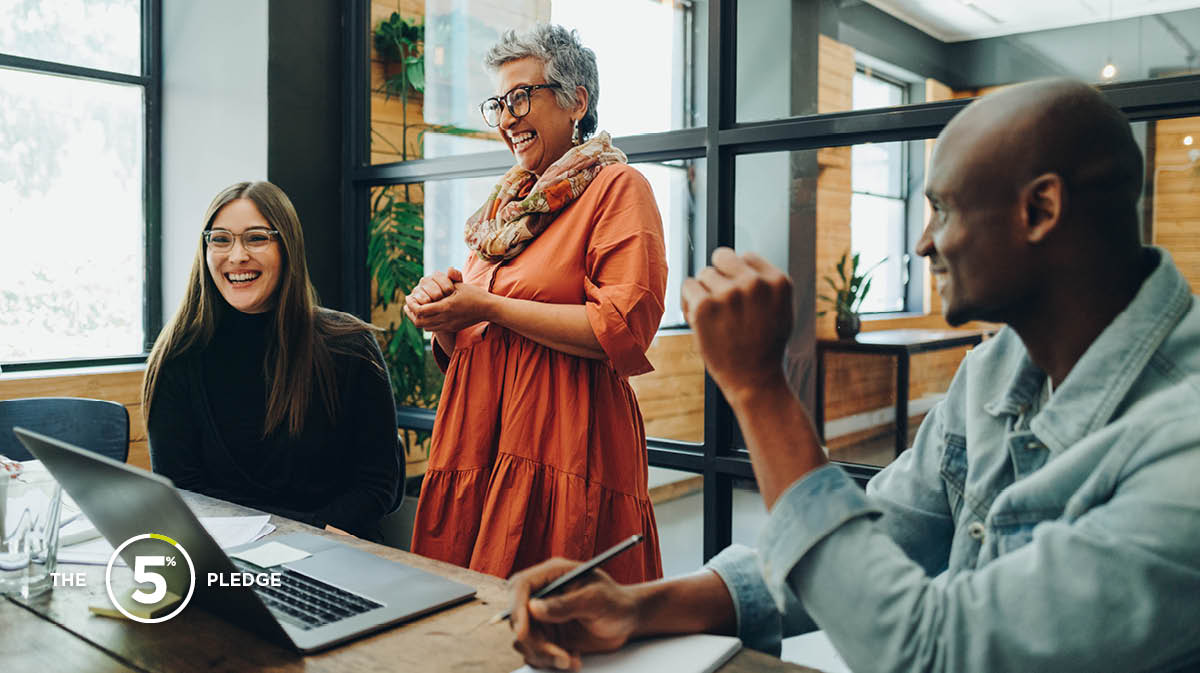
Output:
413 164 667 583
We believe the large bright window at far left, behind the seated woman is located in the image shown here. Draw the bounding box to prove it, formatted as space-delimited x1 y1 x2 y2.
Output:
0 0 158 369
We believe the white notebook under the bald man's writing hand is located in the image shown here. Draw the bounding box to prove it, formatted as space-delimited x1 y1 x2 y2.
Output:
512 633 742 673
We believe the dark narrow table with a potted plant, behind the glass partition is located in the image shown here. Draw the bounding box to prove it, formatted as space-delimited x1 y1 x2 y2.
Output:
816 330 995 456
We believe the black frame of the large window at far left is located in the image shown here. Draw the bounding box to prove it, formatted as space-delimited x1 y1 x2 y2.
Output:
0 0 162 374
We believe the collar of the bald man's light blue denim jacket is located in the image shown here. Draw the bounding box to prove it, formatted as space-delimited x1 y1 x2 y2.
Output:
984 246 1192 455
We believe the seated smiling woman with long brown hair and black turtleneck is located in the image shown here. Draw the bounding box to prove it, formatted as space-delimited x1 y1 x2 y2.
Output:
142 182 403 540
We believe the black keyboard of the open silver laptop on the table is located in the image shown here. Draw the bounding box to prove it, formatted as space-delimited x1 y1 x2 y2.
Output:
233 559 383 631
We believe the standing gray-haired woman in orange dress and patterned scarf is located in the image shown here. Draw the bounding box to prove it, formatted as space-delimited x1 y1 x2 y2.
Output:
404 25 667 582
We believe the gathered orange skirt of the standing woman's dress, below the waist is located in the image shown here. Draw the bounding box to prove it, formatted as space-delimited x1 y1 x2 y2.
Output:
413 325 662 583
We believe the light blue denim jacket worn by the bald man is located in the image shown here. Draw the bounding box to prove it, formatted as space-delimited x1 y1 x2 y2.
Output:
709 248 1200 672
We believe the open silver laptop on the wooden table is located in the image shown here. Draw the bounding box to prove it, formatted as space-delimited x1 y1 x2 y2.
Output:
14 427 475 653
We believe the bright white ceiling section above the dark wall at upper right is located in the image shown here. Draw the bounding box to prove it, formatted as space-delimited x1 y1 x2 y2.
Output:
865 0 1200 42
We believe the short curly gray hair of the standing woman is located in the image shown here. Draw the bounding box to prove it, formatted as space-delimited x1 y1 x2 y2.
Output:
484 23 600 139
